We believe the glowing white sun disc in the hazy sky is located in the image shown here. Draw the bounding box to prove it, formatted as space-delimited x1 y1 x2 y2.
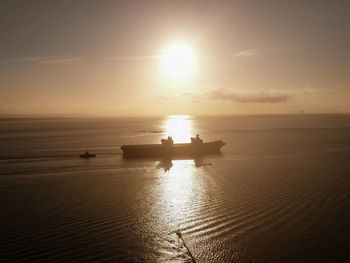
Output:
161 42 197 82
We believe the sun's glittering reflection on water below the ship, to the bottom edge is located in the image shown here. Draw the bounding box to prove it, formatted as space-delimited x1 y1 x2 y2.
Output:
152 159 206 262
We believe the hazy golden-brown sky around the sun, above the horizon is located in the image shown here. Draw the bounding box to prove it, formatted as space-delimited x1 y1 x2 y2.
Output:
0 0 350 117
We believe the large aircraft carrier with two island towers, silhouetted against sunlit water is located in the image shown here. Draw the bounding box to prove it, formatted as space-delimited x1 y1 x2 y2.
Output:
121 135 225 158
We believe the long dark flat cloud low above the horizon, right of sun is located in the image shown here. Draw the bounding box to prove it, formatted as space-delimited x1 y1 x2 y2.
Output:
207 89 291 103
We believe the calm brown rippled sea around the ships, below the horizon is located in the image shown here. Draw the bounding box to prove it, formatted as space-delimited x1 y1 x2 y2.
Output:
0 115 350 262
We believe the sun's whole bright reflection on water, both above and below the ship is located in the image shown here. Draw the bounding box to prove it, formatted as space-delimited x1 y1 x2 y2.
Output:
153 115 206 262
